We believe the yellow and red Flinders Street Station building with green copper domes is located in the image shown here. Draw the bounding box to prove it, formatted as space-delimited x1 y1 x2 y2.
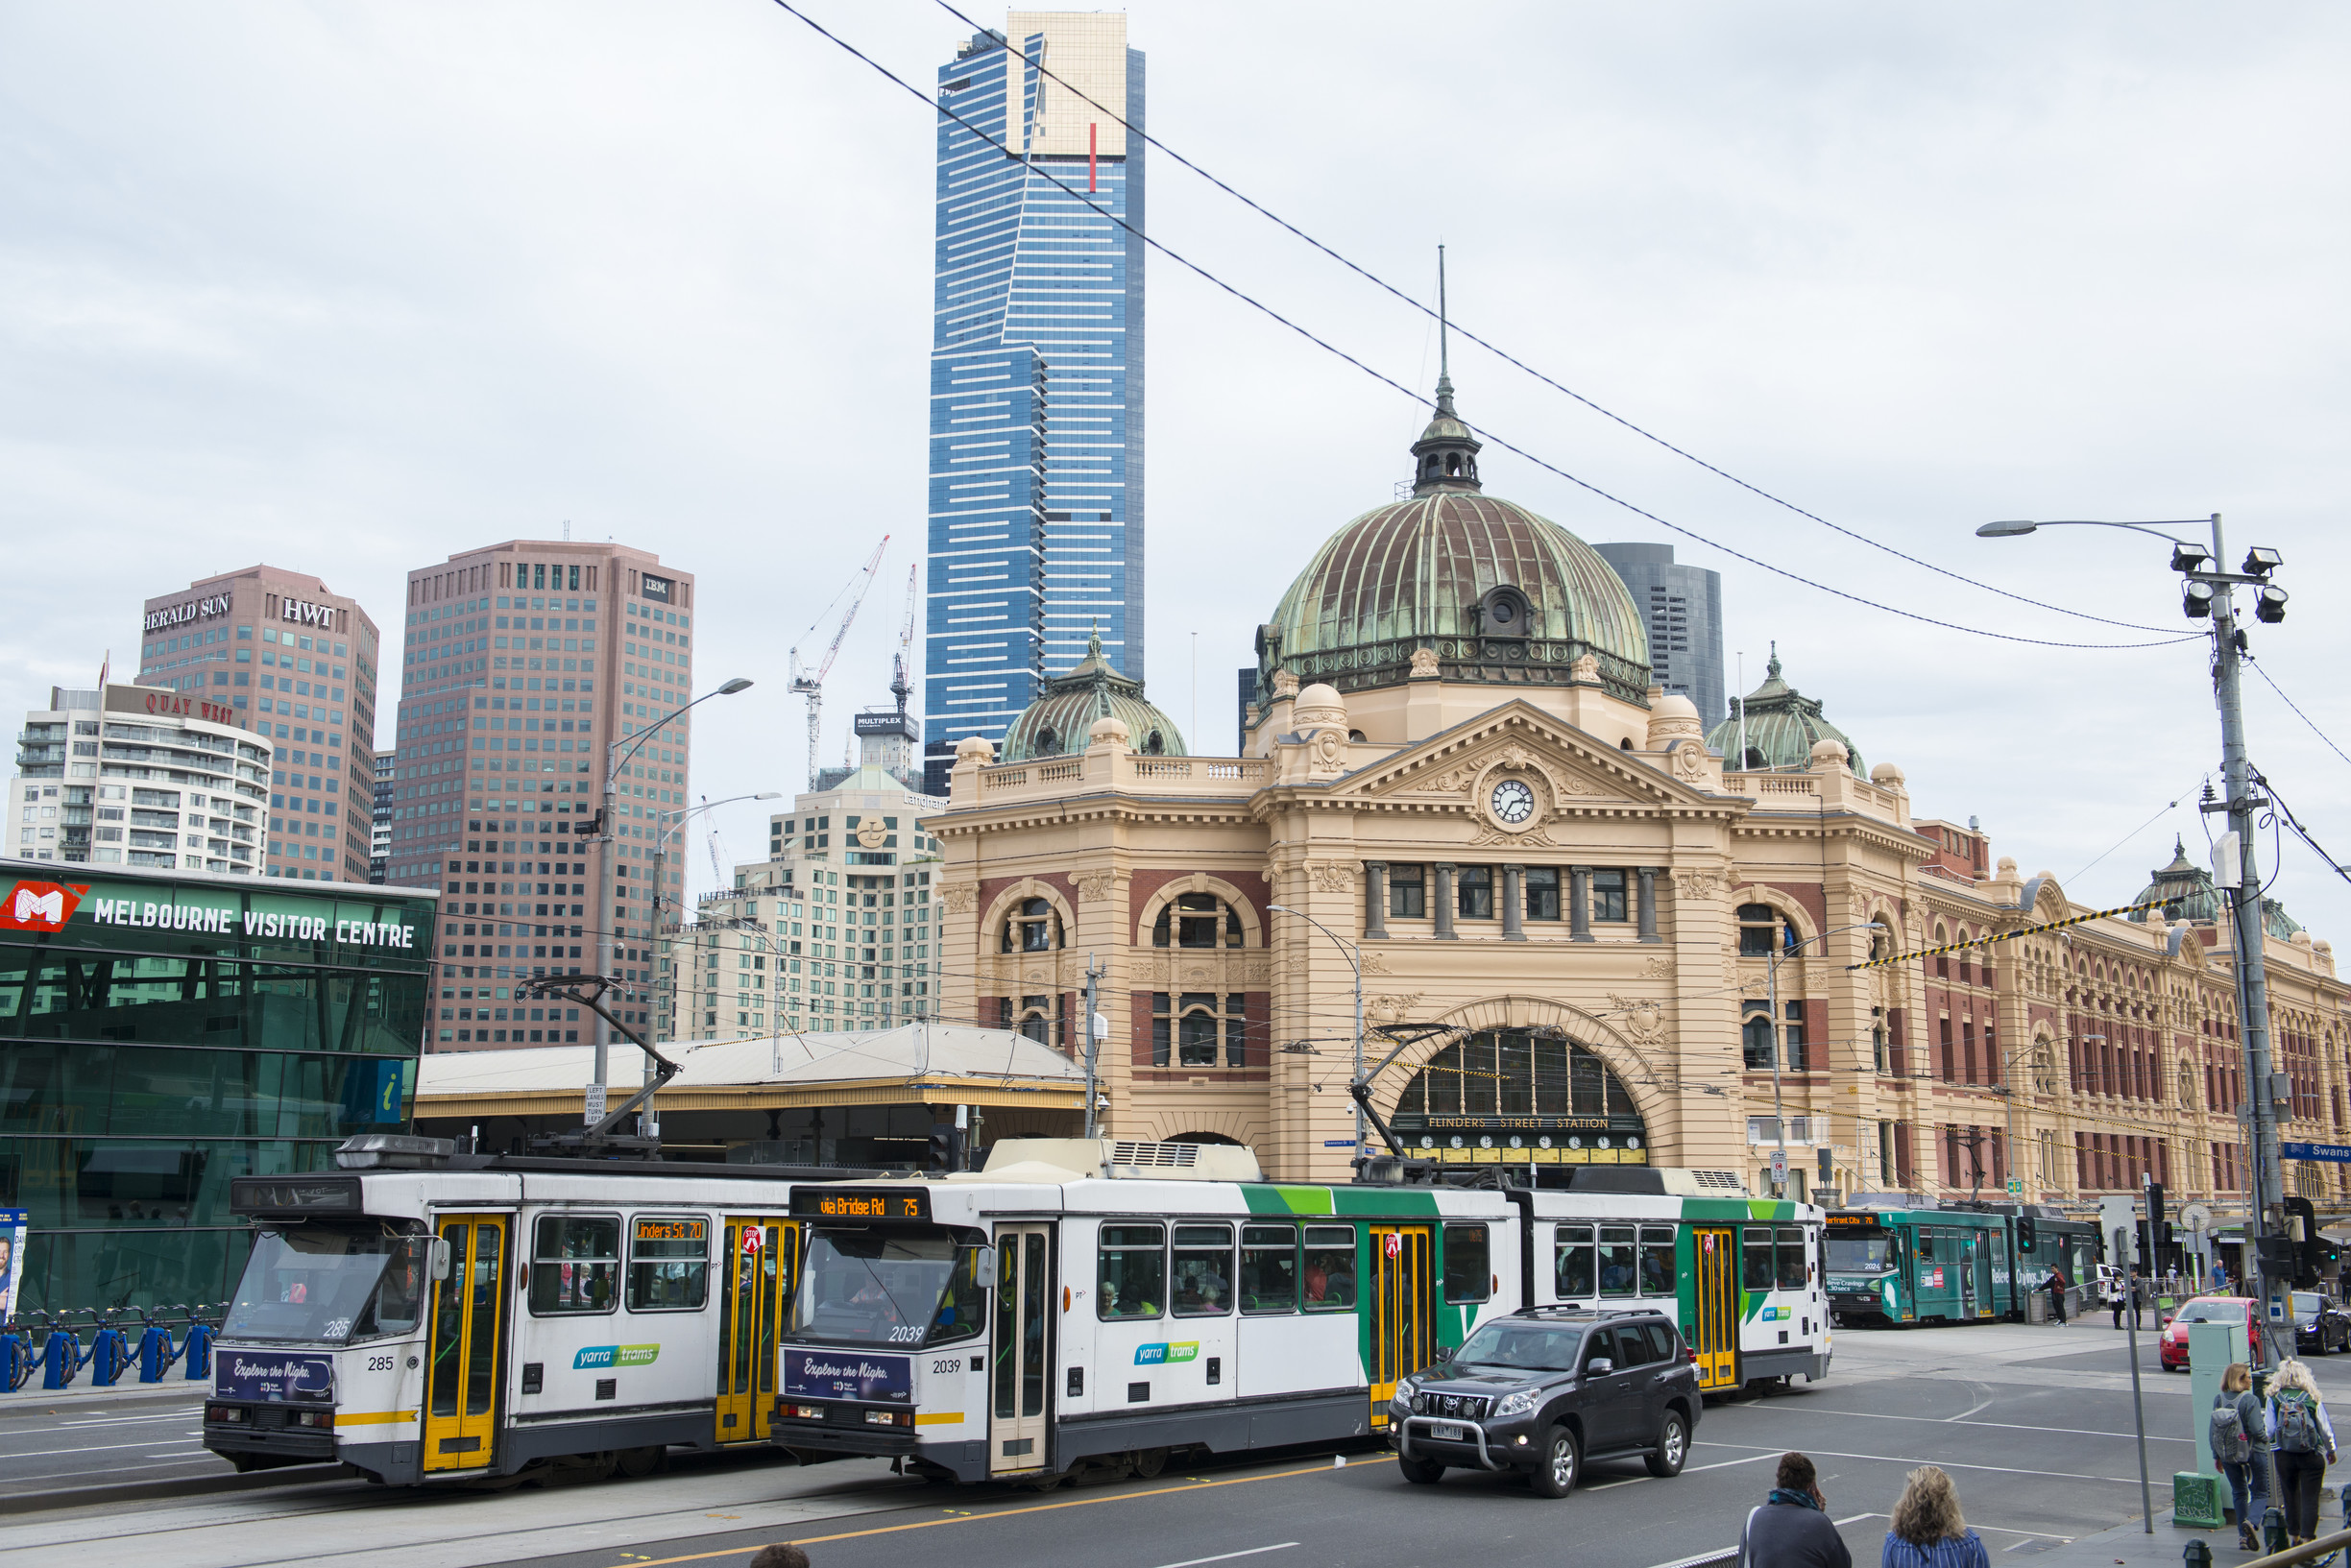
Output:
927 381 2351 1216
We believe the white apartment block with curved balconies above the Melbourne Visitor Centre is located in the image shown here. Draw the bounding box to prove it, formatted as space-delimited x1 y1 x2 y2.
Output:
5 684 273 872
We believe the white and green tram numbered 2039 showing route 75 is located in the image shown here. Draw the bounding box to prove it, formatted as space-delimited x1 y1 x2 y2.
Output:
773 1140 1830 1484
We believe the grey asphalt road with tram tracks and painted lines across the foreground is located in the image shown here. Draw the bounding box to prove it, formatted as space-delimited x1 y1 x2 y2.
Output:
18 1321 2351 1568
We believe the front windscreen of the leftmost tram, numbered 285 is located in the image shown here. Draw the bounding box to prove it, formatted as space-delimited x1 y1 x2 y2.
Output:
221 1225 432 1344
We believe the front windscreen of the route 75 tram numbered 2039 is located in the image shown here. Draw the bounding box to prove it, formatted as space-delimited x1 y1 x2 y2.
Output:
792 1229 987 1344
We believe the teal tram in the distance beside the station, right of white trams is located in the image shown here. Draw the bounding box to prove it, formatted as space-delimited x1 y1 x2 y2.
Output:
1827 1194 2099 1326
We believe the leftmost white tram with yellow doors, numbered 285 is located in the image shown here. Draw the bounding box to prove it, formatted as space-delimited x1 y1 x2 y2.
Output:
205 1136 844 1484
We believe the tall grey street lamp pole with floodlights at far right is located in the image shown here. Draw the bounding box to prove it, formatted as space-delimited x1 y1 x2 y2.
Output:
1977 513 2288 1363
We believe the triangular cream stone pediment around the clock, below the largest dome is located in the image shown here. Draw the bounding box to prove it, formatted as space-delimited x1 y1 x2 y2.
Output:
1333 701 1735 813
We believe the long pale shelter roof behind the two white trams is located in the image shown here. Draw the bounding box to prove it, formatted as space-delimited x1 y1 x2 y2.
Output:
416 1023 1086 1169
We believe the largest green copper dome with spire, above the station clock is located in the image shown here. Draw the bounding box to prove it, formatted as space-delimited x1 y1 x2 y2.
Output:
1258 381 1650 705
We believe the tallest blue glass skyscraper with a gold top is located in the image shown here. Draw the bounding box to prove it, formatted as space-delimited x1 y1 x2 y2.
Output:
924 12 1145 795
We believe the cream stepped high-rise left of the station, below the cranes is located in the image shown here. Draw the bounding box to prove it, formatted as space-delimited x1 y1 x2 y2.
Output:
656 714 948 1039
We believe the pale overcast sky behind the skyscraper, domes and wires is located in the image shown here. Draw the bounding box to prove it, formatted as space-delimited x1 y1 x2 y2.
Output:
0 0 2351 940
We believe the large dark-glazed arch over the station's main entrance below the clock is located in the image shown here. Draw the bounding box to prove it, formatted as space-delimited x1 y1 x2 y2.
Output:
1392 1027 1648 1166
